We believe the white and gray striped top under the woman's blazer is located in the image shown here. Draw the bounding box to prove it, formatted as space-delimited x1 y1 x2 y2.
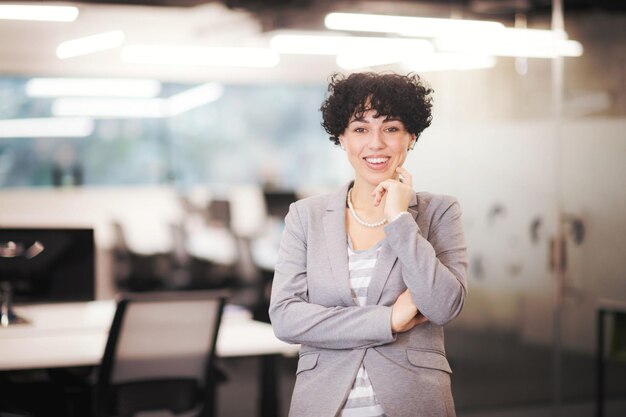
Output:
339 236 386 417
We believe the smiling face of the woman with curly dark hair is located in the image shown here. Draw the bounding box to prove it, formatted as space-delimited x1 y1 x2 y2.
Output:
339 110 415 186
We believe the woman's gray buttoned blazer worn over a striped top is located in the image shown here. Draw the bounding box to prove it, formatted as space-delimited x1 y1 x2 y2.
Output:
269 184 467 417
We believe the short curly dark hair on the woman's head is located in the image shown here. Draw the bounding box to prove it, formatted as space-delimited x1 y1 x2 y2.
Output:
320 72 433 145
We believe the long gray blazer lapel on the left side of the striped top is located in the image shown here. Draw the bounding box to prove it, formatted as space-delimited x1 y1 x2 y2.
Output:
324 184 356 306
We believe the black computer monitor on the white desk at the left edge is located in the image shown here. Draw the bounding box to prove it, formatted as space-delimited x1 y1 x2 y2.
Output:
0 228 95 324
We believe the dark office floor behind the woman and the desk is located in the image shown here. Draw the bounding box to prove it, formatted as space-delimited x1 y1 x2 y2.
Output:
218 330 626 417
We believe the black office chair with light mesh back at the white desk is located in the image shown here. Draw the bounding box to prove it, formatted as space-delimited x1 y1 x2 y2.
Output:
94 291 228 417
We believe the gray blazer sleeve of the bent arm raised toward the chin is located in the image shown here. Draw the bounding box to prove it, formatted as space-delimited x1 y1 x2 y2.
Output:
385 196 468 325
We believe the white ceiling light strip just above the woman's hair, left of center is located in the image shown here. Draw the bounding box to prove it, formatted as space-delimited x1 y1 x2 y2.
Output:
270 34 433 55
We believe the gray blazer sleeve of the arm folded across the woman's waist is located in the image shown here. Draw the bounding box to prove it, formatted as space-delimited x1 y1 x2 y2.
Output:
269 204 395 349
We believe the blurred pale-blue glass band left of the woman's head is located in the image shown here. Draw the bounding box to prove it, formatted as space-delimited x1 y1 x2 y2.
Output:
0 77 332 188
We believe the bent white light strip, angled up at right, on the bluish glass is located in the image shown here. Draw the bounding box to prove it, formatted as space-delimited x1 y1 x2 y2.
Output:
52 83 224 118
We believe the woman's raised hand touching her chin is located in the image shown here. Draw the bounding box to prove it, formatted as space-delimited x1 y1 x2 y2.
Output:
372 167 414 220
